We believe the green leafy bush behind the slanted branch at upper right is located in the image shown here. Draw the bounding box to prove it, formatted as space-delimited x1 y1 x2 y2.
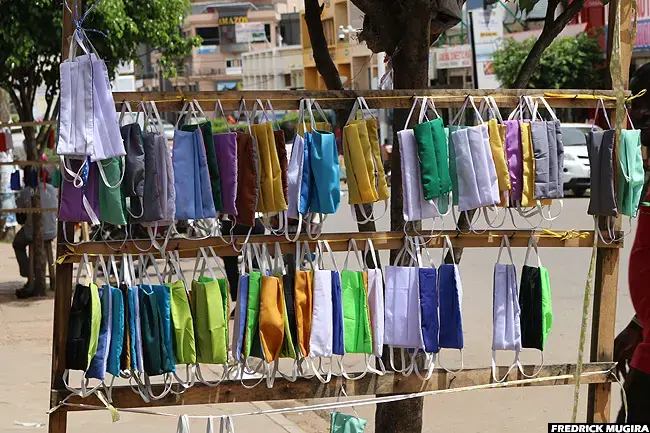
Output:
493 33 605 89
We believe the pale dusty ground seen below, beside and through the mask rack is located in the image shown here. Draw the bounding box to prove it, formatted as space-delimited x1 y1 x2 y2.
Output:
0 199 634 433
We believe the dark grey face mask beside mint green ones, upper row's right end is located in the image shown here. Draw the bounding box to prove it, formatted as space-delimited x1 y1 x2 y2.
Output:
587 129 618 216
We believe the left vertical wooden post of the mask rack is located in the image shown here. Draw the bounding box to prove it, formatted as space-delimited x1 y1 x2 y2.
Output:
48 0 78 433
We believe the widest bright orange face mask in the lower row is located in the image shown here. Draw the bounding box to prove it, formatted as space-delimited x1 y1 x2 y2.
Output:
260 276 285 362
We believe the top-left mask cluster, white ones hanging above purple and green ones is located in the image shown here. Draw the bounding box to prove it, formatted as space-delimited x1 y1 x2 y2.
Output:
56 32 126 224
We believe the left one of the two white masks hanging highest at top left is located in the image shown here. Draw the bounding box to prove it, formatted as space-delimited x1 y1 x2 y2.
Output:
56 42 94 158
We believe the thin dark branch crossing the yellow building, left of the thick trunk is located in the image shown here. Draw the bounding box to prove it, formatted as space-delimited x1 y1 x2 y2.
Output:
305 0 343 90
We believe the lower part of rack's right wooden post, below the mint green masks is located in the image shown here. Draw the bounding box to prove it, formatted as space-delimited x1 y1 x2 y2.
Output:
587 218 620 423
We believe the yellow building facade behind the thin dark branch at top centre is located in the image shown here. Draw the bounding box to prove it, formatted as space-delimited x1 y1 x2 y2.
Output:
300 0 378 90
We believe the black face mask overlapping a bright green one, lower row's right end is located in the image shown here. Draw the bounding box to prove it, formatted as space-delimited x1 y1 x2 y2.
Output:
519 265 544 350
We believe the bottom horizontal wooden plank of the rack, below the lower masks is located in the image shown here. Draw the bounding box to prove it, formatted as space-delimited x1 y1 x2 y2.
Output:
52 362 614 411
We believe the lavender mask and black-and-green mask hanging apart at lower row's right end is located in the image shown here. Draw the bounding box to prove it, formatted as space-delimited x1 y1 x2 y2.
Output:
492 236 553 382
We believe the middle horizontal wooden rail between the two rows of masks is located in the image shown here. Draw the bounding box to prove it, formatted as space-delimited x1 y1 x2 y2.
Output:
58 230 623 263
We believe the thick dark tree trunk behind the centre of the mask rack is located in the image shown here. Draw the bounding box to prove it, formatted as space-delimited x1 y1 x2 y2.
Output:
375 11 431 433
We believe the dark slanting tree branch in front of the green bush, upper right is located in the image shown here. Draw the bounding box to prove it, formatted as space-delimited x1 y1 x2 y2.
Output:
513 0 586 89
